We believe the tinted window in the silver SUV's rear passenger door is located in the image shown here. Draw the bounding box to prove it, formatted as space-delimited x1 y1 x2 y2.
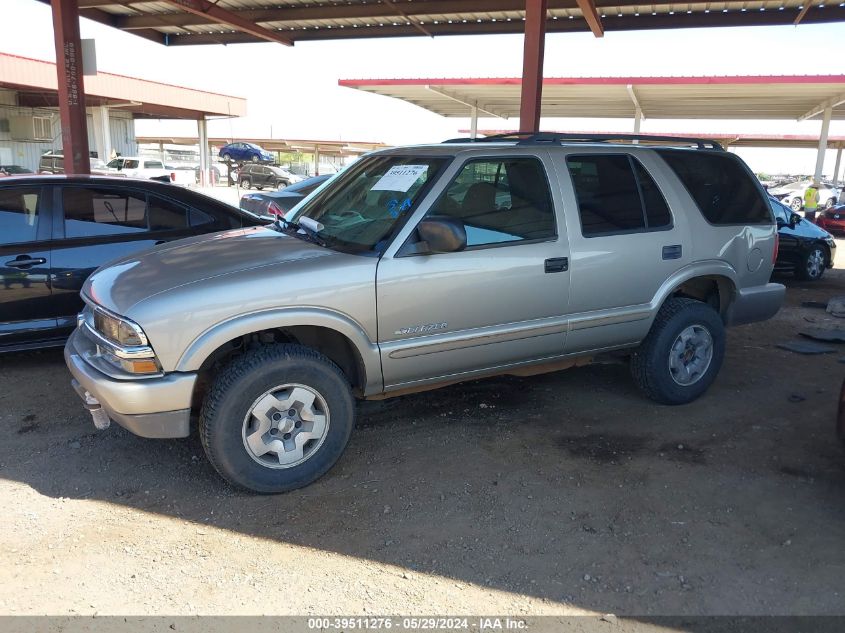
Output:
566 154 672 237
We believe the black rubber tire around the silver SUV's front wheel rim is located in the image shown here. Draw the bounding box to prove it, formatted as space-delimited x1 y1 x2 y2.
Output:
199 344 355 494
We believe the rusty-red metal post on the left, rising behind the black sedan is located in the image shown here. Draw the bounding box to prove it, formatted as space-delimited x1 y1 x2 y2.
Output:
51 0 91 174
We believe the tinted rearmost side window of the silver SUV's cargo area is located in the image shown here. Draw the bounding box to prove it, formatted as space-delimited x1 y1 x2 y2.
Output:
655 149 772 224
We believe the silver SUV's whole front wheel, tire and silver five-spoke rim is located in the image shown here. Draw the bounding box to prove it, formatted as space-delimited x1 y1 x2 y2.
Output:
200 344 355 494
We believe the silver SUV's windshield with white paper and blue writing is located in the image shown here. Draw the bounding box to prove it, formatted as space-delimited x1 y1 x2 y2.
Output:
286 156 450 253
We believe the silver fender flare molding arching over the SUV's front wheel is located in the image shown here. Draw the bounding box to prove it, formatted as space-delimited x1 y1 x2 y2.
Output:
175 307 384 395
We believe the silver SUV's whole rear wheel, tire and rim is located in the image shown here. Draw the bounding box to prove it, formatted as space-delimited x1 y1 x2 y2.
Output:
631 297 725 404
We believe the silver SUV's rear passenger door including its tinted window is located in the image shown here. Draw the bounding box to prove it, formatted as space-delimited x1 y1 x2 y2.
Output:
557 148 692 352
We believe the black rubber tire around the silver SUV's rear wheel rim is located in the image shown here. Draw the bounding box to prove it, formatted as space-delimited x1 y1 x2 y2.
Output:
631 297 725 405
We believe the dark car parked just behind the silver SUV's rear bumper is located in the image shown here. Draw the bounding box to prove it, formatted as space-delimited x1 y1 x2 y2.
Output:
769 197 836 281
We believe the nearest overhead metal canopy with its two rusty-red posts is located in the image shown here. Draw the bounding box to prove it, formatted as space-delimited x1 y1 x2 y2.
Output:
40 0 845 173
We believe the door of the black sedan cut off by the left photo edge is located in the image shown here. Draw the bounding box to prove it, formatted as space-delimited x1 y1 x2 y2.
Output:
0 185 56 345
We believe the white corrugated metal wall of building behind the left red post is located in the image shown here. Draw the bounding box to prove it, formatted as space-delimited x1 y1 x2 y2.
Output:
0 90 138 171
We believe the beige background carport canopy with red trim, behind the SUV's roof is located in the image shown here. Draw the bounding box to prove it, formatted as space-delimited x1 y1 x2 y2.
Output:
338 75 845 120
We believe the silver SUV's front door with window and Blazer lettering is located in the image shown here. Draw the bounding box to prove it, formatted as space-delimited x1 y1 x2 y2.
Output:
377 155 569 390
